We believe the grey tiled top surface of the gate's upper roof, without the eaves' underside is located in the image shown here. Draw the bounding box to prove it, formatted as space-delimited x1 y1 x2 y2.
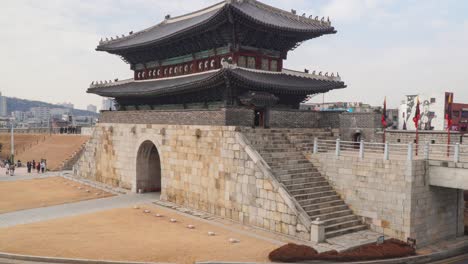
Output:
97 0 335 51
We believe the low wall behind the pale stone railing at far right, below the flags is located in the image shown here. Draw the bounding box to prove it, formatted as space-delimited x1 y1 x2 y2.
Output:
386 130 467 144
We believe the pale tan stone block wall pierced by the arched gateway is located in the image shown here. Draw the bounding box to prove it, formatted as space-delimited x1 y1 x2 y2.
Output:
74 122 310 240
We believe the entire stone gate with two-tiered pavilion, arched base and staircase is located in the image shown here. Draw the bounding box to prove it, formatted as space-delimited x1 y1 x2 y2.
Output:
74 0 464 248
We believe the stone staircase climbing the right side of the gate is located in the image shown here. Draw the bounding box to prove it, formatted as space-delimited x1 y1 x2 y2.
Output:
243 129 367 238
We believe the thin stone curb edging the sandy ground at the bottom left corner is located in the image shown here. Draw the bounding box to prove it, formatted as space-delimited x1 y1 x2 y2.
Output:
0 252 172 264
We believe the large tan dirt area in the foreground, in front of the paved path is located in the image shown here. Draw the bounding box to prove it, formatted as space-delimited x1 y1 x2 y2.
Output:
0 205 279 263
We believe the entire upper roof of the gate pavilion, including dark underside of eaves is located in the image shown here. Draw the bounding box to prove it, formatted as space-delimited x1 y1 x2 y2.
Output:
97 0 336 62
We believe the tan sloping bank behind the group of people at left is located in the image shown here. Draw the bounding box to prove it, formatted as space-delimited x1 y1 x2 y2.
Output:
15 135 89 170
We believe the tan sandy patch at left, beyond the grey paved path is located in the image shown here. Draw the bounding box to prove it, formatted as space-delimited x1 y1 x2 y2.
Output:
0 177 112 214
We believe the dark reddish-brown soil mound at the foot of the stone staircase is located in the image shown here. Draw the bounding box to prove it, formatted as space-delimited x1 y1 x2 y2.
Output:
269 239 416 262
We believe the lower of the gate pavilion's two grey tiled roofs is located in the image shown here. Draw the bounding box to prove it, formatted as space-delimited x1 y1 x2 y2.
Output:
87 64 346 98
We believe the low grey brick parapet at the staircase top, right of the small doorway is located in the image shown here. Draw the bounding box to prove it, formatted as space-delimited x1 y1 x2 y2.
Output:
270 109 320 128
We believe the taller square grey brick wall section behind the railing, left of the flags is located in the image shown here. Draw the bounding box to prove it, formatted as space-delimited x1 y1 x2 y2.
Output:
340 113 382 142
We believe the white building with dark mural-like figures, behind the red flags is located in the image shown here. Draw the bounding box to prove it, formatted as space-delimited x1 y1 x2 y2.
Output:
398 92 453 131
